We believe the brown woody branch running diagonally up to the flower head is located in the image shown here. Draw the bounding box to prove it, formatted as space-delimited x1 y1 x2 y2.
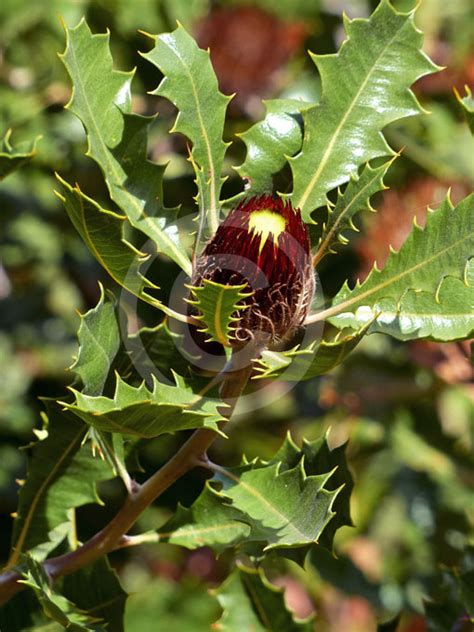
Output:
0 344 258 605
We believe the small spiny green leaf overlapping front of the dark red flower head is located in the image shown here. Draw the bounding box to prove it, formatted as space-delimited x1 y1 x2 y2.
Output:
187 279 252 346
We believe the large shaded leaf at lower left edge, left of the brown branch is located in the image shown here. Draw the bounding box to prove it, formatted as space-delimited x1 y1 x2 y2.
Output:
9 403 114 564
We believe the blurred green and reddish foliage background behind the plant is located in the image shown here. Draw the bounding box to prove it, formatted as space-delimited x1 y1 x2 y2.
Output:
0 0 474 632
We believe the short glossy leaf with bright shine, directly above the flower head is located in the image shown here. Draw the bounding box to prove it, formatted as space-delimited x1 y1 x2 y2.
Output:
236 99 311 195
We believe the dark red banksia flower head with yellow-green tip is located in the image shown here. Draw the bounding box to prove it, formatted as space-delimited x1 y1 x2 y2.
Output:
192 195 314 345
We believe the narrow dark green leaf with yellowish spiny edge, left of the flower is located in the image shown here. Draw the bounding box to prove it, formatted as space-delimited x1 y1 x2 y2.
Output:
58 176 164 309
